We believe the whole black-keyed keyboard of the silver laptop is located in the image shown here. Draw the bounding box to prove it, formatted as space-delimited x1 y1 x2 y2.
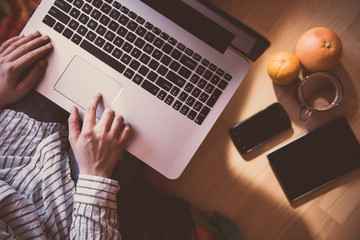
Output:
43 0 232 125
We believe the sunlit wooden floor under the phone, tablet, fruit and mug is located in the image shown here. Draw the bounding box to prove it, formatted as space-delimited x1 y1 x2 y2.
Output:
147 0 360 240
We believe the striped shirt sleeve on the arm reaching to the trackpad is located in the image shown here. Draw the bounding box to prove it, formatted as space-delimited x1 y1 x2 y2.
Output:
70 174 121 239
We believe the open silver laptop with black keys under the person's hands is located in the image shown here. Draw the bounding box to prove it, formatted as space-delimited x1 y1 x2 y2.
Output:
23 0 269 179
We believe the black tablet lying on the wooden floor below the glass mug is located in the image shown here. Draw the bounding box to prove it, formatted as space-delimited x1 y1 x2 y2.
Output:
267 117 360 201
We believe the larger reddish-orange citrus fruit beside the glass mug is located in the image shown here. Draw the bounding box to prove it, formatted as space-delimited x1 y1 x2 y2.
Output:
295 27 343 72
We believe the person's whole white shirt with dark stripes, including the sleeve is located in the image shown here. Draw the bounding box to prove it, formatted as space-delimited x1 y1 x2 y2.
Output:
0 110 121 239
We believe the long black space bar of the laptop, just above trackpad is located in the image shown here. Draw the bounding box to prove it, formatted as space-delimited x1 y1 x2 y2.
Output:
80 40 125 73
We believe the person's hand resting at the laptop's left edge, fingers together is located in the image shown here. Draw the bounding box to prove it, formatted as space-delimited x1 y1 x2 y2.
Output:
0 32 52 108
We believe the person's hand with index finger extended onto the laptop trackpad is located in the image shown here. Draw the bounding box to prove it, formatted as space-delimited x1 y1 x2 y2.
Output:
69 93 131 178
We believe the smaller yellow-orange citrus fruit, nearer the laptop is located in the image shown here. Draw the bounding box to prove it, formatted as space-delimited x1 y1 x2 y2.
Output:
267 52 300 85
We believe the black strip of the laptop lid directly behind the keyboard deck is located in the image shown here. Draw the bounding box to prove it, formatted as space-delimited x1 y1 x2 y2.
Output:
141 0 234 53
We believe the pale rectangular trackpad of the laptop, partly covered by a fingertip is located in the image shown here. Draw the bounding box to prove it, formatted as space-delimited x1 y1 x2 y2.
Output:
55 56 123 118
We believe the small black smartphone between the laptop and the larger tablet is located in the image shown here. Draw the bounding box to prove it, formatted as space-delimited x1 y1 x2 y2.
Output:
229 103 291 153
